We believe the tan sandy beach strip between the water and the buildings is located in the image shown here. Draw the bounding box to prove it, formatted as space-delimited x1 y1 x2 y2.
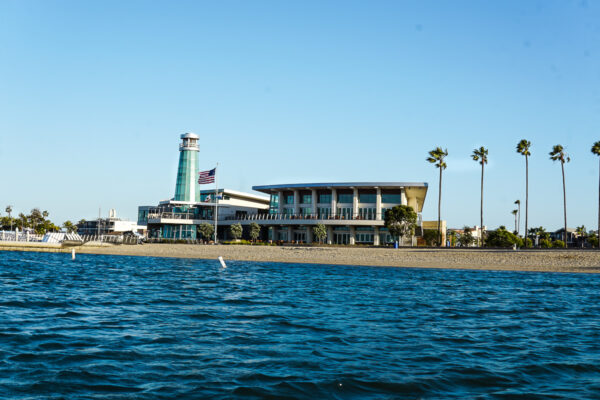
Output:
0 242 600 273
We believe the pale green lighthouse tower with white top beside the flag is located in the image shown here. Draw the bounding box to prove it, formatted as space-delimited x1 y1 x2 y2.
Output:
173 133 200 202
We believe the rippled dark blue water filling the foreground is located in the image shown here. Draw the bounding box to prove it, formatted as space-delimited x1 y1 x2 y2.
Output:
0 252 600 399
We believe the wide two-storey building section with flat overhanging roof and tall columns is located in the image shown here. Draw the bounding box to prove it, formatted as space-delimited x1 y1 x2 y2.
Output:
247 182 427 245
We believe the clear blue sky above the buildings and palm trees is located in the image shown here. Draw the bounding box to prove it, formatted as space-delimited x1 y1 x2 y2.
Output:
0 0 600 230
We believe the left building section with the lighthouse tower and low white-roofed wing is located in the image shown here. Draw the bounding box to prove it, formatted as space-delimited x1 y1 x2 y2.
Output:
138 133 269 239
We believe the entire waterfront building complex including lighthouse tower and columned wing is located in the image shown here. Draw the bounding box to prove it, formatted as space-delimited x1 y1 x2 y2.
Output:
138 133 434 245
